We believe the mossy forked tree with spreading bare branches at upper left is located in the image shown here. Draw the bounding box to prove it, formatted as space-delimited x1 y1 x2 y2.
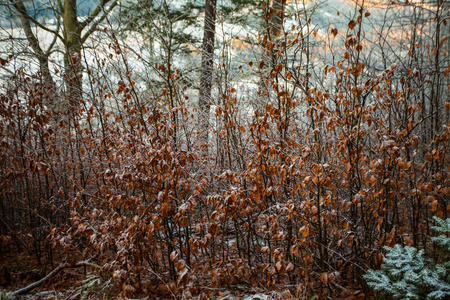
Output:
2 0 118 100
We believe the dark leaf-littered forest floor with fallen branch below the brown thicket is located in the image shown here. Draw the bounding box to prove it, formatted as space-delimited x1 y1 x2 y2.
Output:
0 245 367 300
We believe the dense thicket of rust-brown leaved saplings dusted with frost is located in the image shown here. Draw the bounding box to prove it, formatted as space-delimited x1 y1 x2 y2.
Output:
0 1 450 297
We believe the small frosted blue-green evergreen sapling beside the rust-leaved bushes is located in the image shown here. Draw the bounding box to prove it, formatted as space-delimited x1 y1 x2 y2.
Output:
364 217 450 299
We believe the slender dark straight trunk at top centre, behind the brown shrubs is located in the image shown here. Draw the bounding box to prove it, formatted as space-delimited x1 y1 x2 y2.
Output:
198 0 216 152
